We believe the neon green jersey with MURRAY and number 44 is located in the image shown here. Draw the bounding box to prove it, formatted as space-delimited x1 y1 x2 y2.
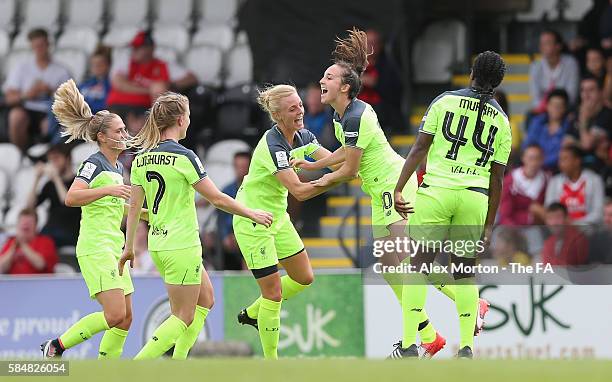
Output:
419 89 512 189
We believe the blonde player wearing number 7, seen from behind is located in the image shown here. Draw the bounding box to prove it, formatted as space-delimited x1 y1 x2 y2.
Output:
119 92 272 359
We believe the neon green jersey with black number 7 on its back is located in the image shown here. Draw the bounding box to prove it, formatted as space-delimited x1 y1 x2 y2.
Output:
131 140 206 251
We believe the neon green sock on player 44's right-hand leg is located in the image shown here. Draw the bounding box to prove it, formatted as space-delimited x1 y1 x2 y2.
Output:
455 278 478 350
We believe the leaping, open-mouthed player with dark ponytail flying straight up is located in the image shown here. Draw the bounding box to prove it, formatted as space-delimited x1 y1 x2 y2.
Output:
292 29 454 357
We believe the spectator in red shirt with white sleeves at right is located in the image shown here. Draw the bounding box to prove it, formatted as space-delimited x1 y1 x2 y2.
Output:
544 145 604 224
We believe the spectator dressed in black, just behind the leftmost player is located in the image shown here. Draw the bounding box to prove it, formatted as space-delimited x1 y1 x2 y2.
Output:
28 143 81 247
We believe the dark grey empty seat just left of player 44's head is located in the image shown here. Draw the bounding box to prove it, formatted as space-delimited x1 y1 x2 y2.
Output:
412 20 466 83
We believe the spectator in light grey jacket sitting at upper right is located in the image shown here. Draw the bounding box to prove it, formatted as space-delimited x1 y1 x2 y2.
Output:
529 29 580 114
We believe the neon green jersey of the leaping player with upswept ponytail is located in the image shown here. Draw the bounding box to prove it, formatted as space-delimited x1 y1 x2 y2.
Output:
334 98 404 192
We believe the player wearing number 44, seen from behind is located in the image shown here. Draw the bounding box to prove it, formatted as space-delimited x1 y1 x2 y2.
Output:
393 51 512 358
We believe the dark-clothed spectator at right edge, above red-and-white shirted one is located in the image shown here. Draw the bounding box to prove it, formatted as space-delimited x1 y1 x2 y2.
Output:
570 75 612 152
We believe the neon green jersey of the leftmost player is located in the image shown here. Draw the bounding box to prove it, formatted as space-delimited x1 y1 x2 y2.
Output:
75 151 125 259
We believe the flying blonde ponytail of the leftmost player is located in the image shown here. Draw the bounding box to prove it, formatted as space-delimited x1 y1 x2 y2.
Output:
51 79 116 142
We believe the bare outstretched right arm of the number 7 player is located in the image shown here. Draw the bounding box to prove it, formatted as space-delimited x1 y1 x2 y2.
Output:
193 177 272 227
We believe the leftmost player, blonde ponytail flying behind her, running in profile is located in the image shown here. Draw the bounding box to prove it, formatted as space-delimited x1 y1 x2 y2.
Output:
41 80 145 358
